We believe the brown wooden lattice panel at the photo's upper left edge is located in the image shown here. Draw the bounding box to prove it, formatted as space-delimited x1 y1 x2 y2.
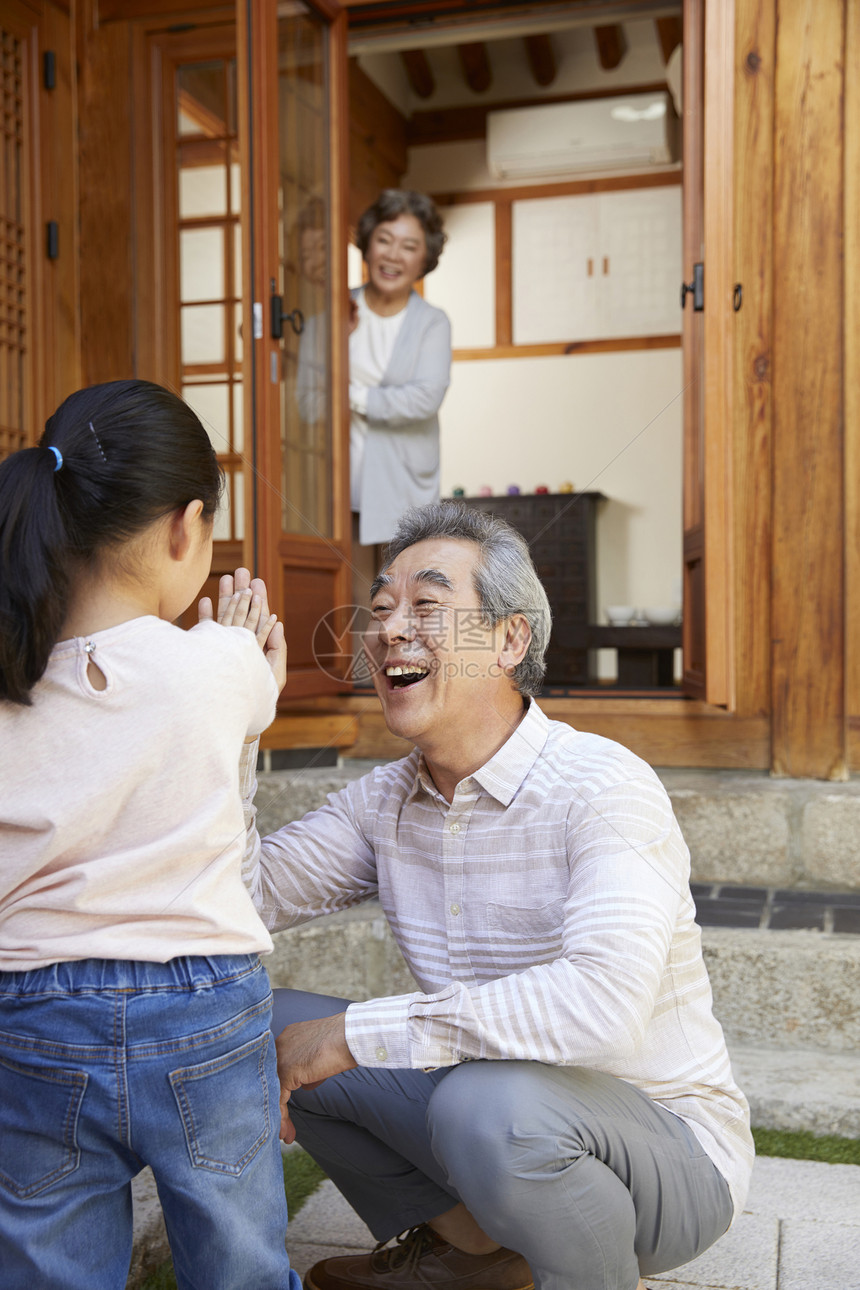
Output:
0 28 27 457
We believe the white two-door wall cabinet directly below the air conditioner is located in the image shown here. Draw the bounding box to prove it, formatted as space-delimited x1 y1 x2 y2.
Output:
512 184 681 344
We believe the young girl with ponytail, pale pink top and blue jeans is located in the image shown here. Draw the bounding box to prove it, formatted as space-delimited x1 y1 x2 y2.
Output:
0 381 299 1290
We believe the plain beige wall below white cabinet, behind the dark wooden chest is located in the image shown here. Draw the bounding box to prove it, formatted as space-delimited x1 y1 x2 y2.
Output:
441 350 681 624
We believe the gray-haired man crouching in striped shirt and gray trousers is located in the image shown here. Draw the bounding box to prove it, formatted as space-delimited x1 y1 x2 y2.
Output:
238 503 753 1290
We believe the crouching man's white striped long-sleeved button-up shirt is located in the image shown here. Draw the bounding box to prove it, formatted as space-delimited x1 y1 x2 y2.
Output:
246 702 753 1213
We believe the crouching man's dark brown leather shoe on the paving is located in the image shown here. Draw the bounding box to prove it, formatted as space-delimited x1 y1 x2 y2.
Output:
304 1223 534 1290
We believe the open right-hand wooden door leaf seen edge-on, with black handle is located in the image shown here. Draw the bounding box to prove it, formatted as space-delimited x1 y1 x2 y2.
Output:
683 0 738 711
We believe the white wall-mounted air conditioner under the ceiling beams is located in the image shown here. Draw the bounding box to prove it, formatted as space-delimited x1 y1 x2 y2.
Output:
487 92 679 179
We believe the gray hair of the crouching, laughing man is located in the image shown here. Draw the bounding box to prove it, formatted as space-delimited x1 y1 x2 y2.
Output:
382 502 552 695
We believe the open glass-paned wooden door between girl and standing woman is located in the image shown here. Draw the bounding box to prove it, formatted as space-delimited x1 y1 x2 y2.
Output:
237 0 351 703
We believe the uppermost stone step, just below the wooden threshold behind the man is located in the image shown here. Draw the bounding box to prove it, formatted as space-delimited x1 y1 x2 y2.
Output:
257 760 860 891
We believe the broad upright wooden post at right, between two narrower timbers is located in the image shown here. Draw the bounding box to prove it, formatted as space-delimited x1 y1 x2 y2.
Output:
771 0 850 779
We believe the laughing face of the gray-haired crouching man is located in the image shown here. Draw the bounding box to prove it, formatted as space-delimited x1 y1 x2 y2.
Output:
365 538 512 752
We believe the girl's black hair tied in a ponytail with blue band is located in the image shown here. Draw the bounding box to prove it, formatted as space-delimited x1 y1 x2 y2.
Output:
0 381 223 704
